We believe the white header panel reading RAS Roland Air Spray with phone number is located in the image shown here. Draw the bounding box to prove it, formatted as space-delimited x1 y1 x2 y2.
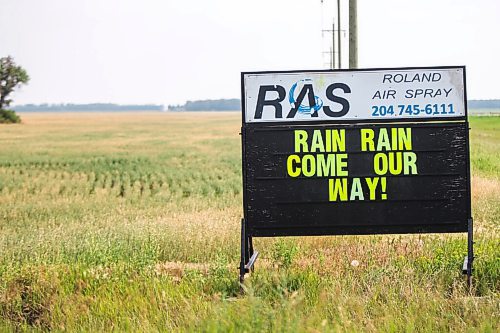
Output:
242 67 466 123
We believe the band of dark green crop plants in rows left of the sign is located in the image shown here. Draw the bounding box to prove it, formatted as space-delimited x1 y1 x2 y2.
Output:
0 168 241 197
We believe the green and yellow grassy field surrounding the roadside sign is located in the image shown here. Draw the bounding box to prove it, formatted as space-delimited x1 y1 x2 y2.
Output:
0 113 500 332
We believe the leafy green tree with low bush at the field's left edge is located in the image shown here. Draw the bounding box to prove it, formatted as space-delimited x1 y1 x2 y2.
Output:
0 56 30 123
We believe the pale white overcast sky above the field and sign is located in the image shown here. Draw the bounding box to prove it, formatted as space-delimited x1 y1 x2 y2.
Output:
0 0 500 104
